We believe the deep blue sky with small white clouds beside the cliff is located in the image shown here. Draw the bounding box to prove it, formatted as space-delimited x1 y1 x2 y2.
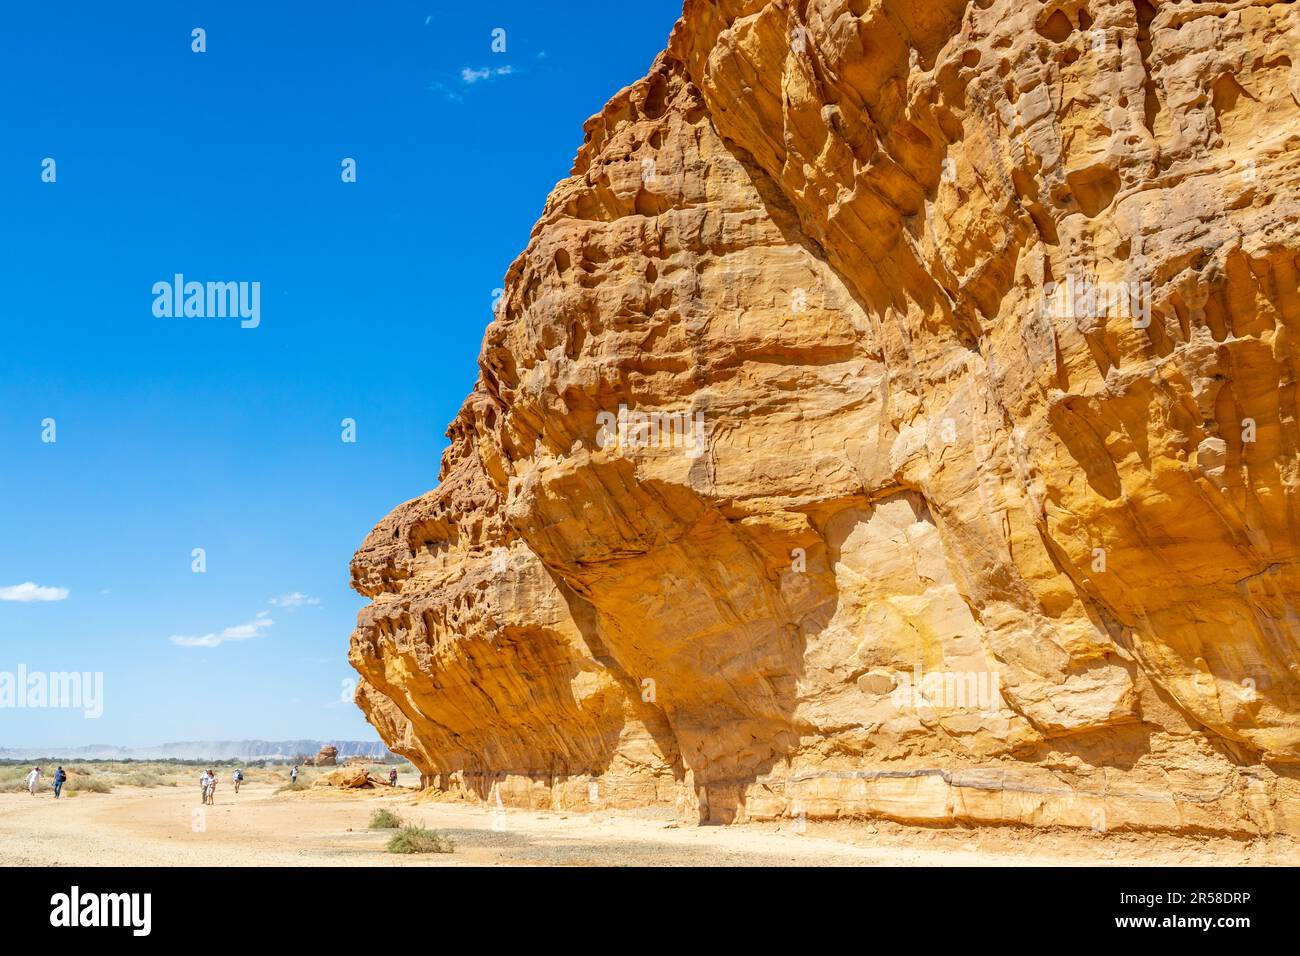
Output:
0 0 681 747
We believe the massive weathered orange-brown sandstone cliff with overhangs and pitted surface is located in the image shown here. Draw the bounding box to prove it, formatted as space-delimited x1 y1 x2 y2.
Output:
350 0 1300 834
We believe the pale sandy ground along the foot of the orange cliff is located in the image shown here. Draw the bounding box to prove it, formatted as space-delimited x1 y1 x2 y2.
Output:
0 784 1300 866
